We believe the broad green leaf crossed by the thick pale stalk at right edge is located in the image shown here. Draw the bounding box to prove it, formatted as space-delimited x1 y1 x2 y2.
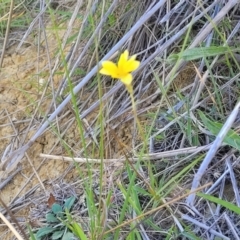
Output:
198 111 240 150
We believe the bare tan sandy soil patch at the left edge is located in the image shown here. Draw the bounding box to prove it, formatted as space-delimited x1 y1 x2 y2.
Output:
0 26 81 239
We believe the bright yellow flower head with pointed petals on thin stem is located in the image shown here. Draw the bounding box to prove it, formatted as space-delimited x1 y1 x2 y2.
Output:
99 50 140 86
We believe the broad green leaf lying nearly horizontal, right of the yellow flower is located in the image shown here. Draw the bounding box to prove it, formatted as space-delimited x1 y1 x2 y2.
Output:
167 46 239 62
